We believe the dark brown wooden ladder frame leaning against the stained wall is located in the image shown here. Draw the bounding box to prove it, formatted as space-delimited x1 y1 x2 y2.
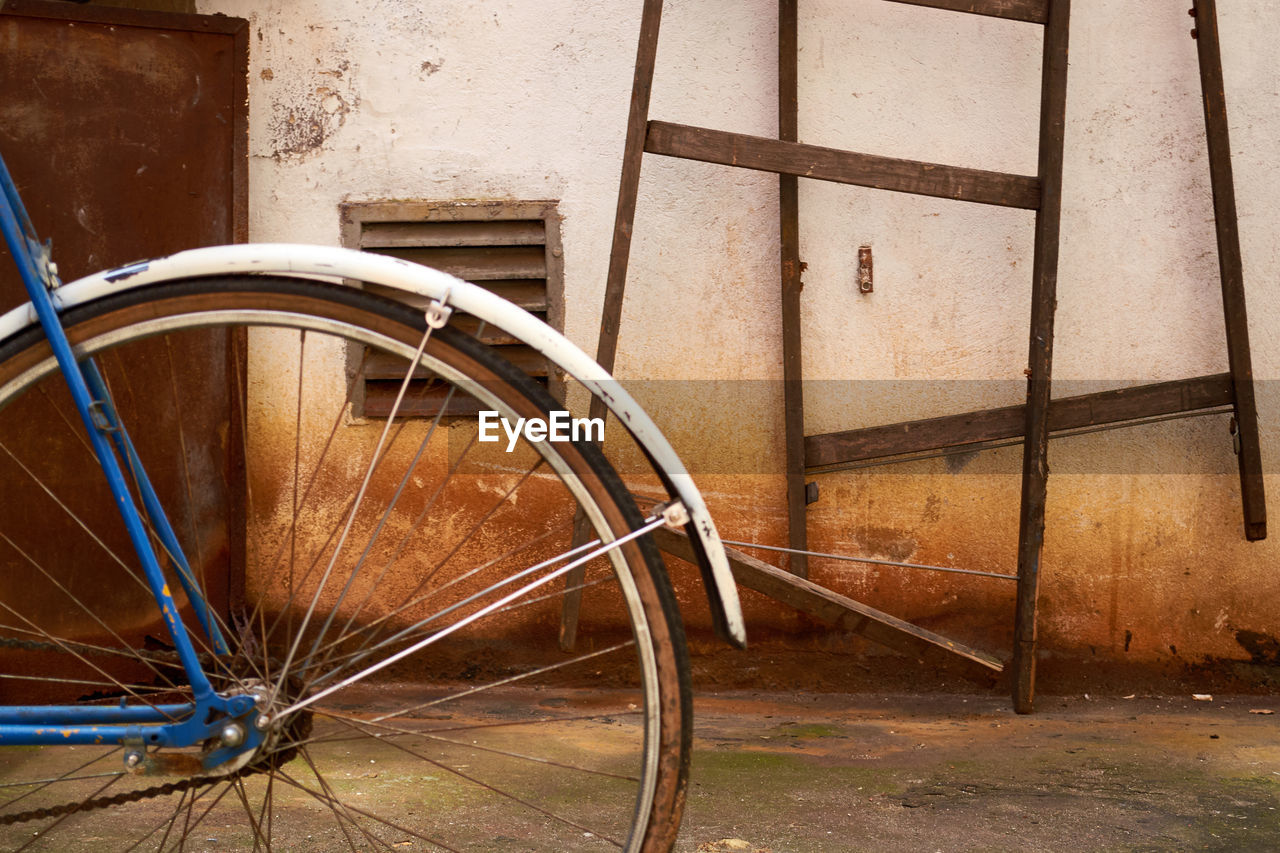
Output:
562 0 1266 713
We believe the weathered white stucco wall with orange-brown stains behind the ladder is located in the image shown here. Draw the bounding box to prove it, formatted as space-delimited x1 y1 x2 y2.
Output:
200 0 1280 686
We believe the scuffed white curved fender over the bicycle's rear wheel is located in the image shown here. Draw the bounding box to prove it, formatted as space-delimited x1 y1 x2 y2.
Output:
0 243 746 646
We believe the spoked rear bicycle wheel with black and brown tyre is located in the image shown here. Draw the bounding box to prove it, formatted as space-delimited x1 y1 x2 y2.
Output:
0 275 690 850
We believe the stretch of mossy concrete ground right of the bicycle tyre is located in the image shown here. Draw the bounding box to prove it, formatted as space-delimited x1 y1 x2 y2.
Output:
677 693 1280 853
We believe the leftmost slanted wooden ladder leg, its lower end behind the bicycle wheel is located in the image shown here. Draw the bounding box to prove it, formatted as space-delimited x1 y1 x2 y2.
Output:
559 0 662 651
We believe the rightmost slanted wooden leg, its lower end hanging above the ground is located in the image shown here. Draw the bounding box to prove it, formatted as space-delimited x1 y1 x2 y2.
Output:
1192 0 1267 542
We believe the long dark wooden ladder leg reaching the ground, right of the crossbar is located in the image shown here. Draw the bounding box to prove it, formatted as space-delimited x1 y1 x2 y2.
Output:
1012 0 1071 713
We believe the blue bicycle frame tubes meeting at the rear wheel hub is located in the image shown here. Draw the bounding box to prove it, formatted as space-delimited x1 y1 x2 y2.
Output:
0 151 262 770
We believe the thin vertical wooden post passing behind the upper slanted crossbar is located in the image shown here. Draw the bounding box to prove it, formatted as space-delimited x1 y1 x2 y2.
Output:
778 0 809 578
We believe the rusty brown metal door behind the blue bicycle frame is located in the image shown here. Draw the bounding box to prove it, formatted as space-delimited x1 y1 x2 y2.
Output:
0 0 248 696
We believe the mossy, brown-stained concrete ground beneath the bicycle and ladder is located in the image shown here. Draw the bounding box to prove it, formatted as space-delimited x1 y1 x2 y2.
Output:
0 685 1280 853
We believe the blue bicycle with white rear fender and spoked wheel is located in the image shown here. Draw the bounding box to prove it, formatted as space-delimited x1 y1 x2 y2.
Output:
0 149 744 850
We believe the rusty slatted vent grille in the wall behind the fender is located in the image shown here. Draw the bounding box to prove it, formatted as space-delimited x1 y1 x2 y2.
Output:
342 201 563 418
